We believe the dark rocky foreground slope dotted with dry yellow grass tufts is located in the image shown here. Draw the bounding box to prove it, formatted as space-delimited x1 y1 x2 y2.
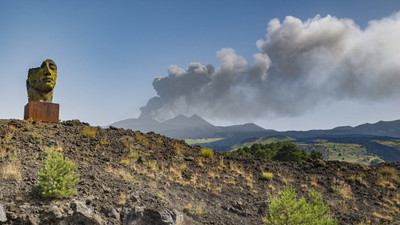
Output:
0 120 400 225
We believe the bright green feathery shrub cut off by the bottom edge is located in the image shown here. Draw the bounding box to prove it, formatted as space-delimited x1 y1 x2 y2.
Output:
264 186 337 225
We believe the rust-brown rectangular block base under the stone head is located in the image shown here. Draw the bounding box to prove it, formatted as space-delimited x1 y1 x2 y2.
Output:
24 102 60 123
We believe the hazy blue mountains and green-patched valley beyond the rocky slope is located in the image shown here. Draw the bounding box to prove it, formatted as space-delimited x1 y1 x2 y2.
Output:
110 115 400 164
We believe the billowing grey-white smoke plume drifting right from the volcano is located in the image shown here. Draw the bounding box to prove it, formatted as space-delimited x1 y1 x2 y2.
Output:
141 13 400 120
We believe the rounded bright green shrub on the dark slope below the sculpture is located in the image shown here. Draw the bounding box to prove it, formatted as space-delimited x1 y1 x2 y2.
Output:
38 151 79 198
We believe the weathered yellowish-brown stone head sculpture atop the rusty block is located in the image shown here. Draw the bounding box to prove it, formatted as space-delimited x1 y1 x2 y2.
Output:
26 59 57 103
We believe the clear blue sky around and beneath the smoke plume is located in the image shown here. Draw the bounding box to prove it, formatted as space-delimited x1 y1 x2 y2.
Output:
0 0 400 130
